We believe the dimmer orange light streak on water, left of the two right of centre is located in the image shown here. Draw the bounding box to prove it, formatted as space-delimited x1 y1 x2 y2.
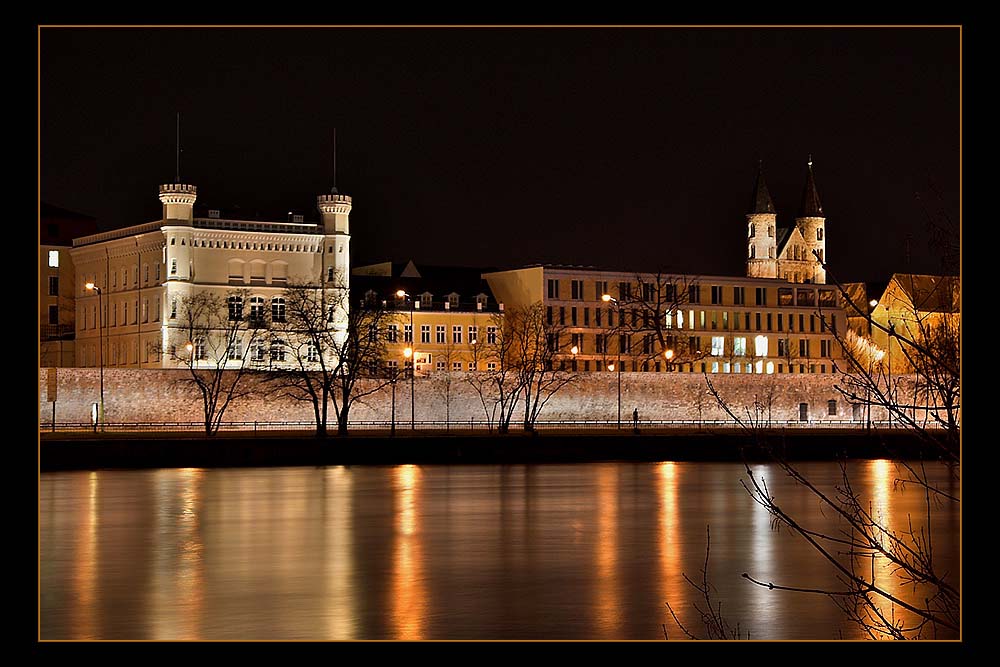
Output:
594 464 621 639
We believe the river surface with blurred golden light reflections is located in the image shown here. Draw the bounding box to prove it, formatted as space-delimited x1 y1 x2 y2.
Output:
39 462 959 639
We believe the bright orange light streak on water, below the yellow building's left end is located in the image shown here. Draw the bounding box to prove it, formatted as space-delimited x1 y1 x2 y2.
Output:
389 465 427 639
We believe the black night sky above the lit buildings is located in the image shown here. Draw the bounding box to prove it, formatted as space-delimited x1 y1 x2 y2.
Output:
40 28 960 280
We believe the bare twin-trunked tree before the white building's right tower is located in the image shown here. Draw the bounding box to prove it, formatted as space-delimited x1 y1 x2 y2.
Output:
268 283 398 437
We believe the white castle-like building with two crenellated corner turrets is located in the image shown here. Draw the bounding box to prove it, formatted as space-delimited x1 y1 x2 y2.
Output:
70 183 351 368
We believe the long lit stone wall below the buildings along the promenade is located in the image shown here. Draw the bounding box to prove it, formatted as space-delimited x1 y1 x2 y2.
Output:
39 368 923 425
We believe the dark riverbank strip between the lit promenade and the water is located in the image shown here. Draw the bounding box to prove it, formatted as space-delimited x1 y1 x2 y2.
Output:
39 429 936 471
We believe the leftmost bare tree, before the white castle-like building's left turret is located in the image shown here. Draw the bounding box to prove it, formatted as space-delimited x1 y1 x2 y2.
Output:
158 290 264 435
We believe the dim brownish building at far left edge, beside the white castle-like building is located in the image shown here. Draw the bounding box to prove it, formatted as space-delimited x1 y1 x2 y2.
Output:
38 203 97 368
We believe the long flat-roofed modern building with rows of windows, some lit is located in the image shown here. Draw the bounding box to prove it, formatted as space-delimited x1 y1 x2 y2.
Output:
484 266 847 374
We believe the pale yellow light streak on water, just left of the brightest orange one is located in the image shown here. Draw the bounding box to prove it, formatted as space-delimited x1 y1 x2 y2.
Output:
323 466 358 640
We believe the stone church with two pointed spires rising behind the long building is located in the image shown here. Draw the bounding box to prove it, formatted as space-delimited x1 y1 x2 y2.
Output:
747 156 826 285
